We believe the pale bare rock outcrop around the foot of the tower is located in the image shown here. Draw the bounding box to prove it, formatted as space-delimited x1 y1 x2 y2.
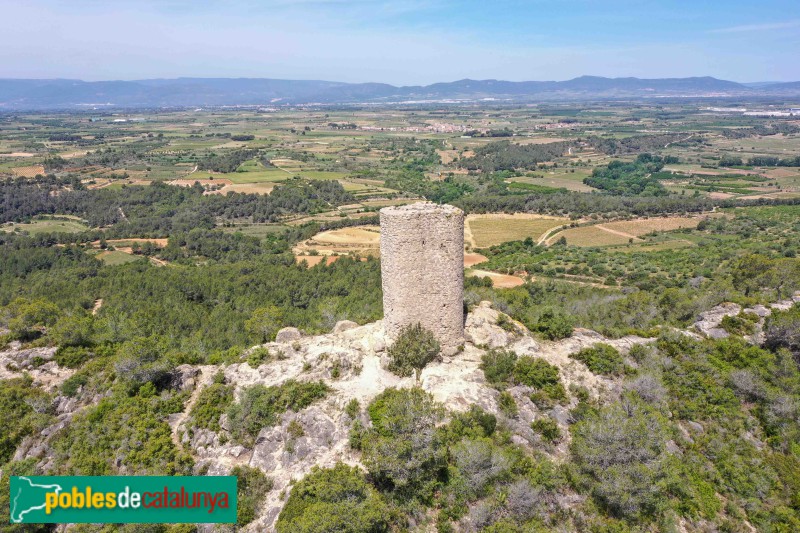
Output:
177 302 664 531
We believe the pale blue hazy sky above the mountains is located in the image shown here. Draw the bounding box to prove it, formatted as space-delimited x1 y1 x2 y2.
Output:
0 0 800 85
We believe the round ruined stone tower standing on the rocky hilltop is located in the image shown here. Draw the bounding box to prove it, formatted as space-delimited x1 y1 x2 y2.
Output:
380 202 464 354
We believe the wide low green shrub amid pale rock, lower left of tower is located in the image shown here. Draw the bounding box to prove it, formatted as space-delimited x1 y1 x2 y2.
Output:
228 379 330 446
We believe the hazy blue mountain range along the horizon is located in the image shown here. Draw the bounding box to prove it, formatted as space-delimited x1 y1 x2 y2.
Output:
0 76 800 111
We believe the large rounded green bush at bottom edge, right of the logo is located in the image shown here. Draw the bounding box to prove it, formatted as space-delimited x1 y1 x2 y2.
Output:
276 463 392 533
